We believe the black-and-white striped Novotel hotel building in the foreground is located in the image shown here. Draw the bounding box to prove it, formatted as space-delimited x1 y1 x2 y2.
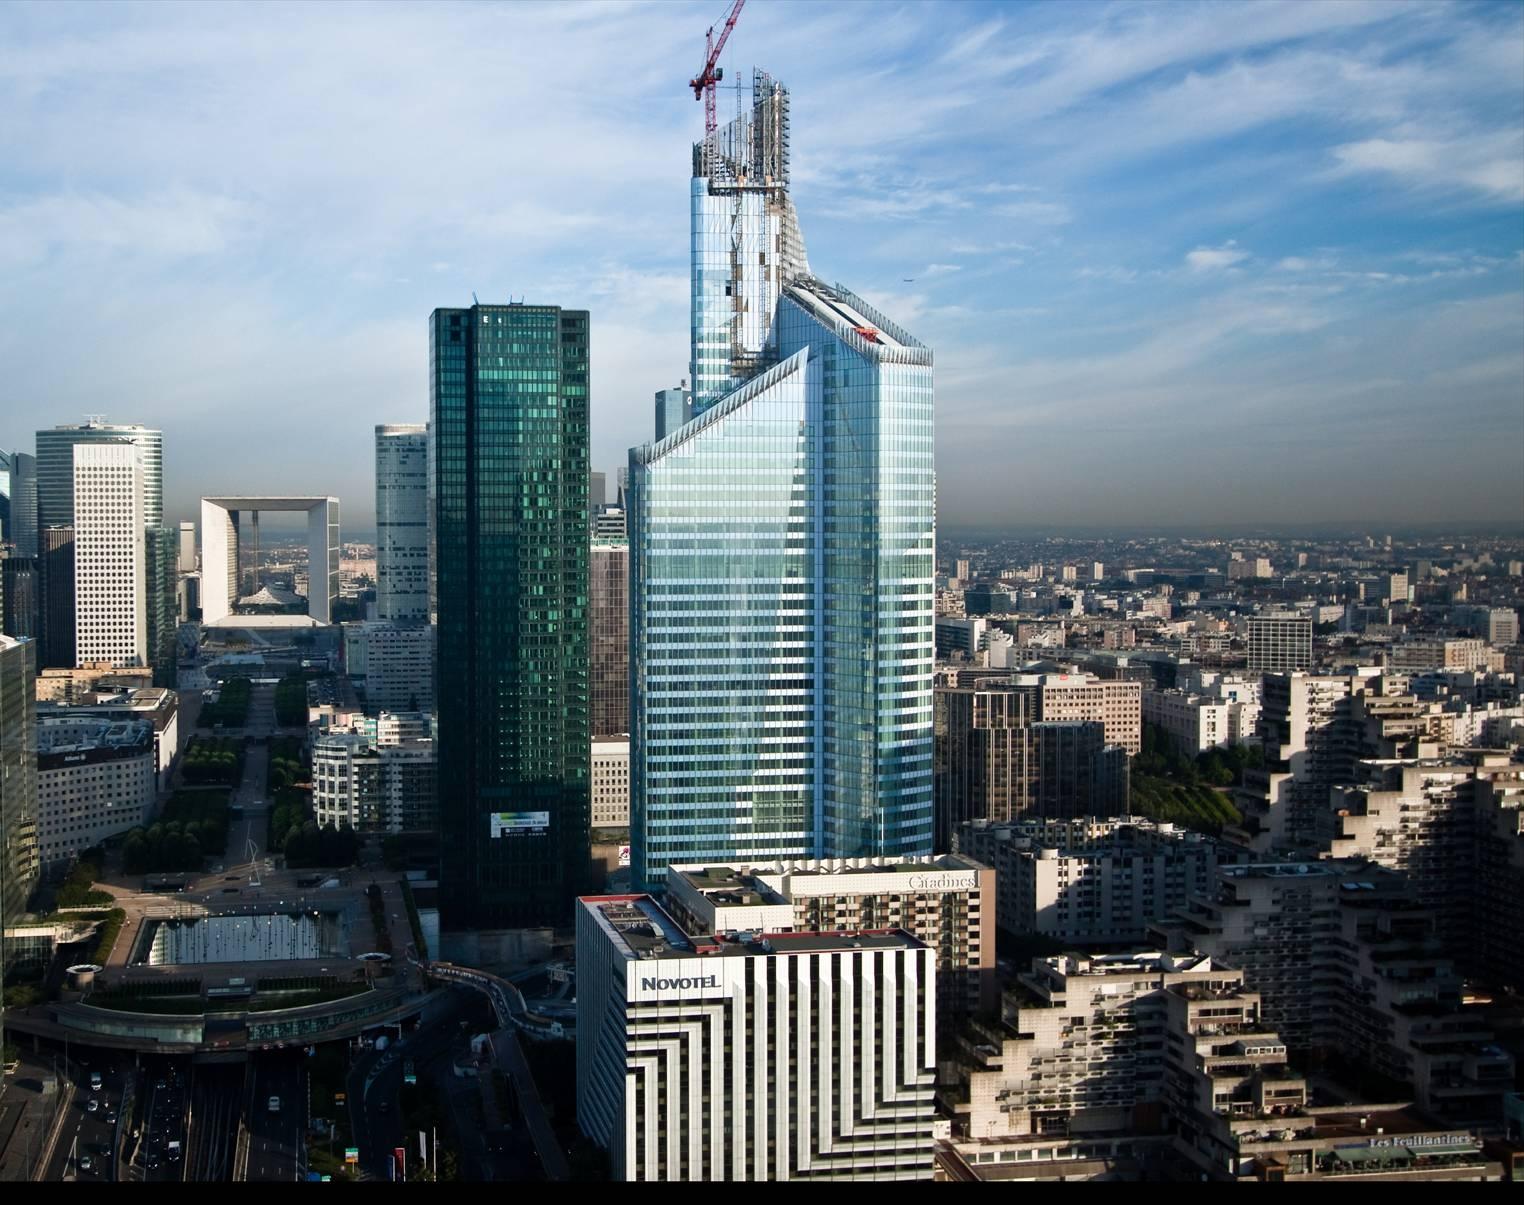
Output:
576 894 936 1182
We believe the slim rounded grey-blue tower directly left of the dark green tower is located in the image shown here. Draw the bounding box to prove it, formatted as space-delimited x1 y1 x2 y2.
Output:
376 424 428 623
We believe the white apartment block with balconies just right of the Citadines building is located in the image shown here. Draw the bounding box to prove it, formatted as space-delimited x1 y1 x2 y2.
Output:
957 817 1242 946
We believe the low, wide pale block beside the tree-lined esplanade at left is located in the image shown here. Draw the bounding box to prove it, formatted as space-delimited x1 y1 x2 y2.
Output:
37 722 158 870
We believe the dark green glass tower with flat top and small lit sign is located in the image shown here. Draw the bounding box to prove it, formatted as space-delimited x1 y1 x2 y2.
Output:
430 305 590 929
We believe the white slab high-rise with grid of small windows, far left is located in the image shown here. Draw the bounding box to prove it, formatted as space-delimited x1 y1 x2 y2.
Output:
73 442 148 666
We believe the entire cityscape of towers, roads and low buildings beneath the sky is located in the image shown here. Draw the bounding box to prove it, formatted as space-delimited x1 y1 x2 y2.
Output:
0 0 1524 1187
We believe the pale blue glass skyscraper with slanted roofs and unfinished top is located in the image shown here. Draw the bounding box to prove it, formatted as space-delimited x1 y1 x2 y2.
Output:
629 73 934 885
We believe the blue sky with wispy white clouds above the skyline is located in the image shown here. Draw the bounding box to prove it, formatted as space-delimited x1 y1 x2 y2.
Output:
0 0 1524 529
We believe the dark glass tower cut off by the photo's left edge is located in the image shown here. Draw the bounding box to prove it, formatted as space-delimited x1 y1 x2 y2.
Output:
0 635 38 928
